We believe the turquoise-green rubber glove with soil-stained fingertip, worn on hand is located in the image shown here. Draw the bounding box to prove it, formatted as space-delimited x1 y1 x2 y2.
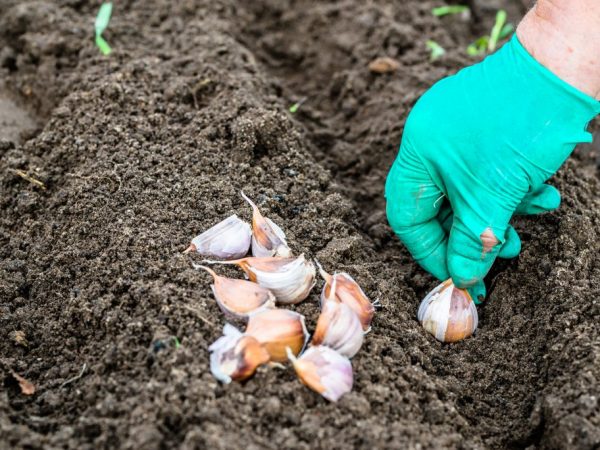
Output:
385 35 600 302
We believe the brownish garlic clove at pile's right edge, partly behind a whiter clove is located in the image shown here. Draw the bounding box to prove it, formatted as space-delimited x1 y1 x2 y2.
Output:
317 262 375 331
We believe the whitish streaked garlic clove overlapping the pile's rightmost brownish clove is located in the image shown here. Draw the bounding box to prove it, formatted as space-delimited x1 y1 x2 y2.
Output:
311 298 364 358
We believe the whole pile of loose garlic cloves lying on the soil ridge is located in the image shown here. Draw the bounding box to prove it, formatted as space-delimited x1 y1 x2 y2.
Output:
184 192 375 402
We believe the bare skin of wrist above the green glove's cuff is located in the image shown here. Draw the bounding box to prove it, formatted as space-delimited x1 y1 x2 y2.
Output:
517 0 600 99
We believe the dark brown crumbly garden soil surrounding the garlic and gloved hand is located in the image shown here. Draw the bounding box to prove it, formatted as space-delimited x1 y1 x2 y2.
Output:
0 0 600 449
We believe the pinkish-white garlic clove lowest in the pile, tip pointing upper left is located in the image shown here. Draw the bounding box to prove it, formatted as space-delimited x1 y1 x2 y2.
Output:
288 346 353 402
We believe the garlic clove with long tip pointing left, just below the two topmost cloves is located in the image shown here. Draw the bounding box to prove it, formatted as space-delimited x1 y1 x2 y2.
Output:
205 255 316 305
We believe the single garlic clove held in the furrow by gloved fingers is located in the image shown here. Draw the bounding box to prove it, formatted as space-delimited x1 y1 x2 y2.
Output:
417 280 479 342
